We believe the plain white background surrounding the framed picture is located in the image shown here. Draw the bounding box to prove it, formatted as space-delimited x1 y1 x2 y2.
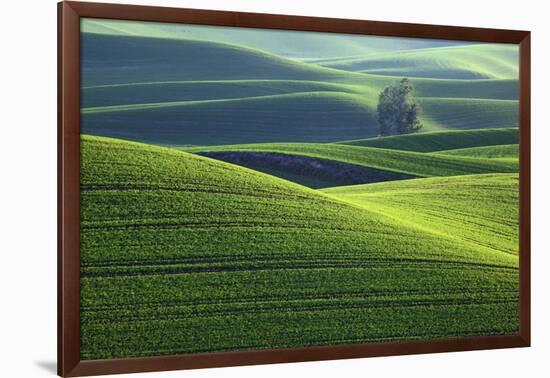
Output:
0 0 550 378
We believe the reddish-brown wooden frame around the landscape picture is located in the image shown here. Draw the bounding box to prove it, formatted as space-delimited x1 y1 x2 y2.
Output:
58 2 531 377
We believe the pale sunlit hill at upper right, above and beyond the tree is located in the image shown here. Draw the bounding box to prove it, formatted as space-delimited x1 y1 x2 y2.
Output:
316 44 518 79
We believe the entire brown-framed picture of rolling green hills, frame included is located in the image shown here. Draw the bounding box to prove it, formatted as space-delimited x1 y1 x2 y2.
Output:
58 2 530 376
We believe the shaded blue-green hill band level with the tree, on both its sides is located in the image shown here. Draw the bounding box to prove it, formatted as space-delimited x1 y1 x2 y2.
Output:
82 92 518 146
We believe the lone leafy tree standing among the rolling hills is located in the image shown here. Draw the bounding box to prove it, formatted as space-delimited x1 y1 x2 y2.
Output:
377 78 422 135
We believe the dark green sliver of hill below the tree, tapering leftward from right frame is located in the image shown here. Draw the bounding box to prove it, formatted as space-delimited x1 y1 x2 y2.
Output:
340 128 519 152
